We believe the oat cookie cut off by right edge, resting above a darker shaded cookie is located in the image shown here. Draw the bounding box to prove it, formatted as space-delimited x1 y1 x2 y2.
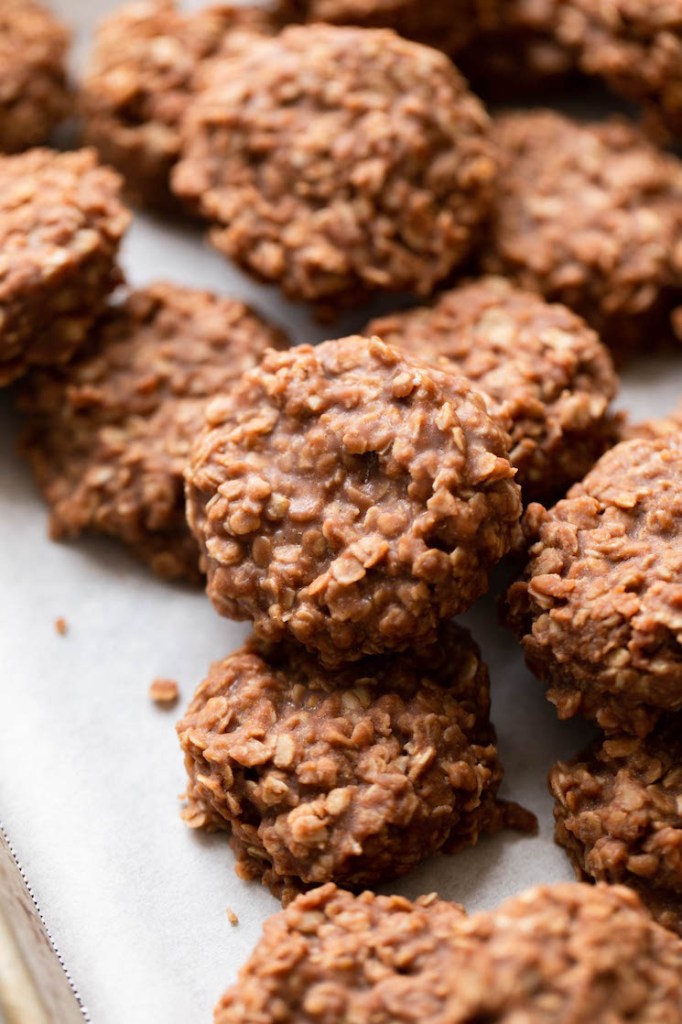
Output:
507 435 682 735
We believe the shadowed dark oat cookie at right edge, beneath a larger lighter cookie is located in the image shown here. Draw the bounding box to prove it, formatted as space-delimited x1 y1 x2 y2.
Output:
550 715 682 934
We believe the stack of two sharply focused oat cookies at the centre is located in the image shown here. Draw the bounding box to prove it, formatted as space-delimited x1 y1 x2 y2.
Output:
178 337 532 900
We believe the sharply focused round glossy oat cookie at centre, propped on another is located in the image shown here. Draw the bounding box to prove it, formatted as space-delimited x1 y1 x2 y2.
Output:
186 337 520 664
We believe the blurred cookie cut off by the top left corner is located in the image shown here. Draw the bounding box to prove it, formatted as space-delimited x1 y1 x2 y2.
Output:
0 0 71 153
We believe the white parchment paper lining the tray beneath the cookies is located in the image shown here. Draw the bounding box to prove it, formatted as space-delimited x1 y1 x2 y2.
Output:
0 0 682 1024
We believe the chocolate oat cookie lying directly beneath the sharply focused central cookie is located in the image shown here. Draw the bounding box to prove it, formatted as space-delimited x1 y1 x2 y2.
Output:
178 626 535 901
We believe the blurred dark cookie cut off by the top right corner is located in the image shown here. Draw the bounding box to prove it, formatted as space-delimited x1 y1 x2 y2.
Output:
557 0 682 136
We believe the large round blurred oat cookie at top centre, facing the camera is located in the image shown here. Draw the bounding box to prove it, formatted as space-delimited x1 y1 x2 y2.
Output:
172 25 496 304
